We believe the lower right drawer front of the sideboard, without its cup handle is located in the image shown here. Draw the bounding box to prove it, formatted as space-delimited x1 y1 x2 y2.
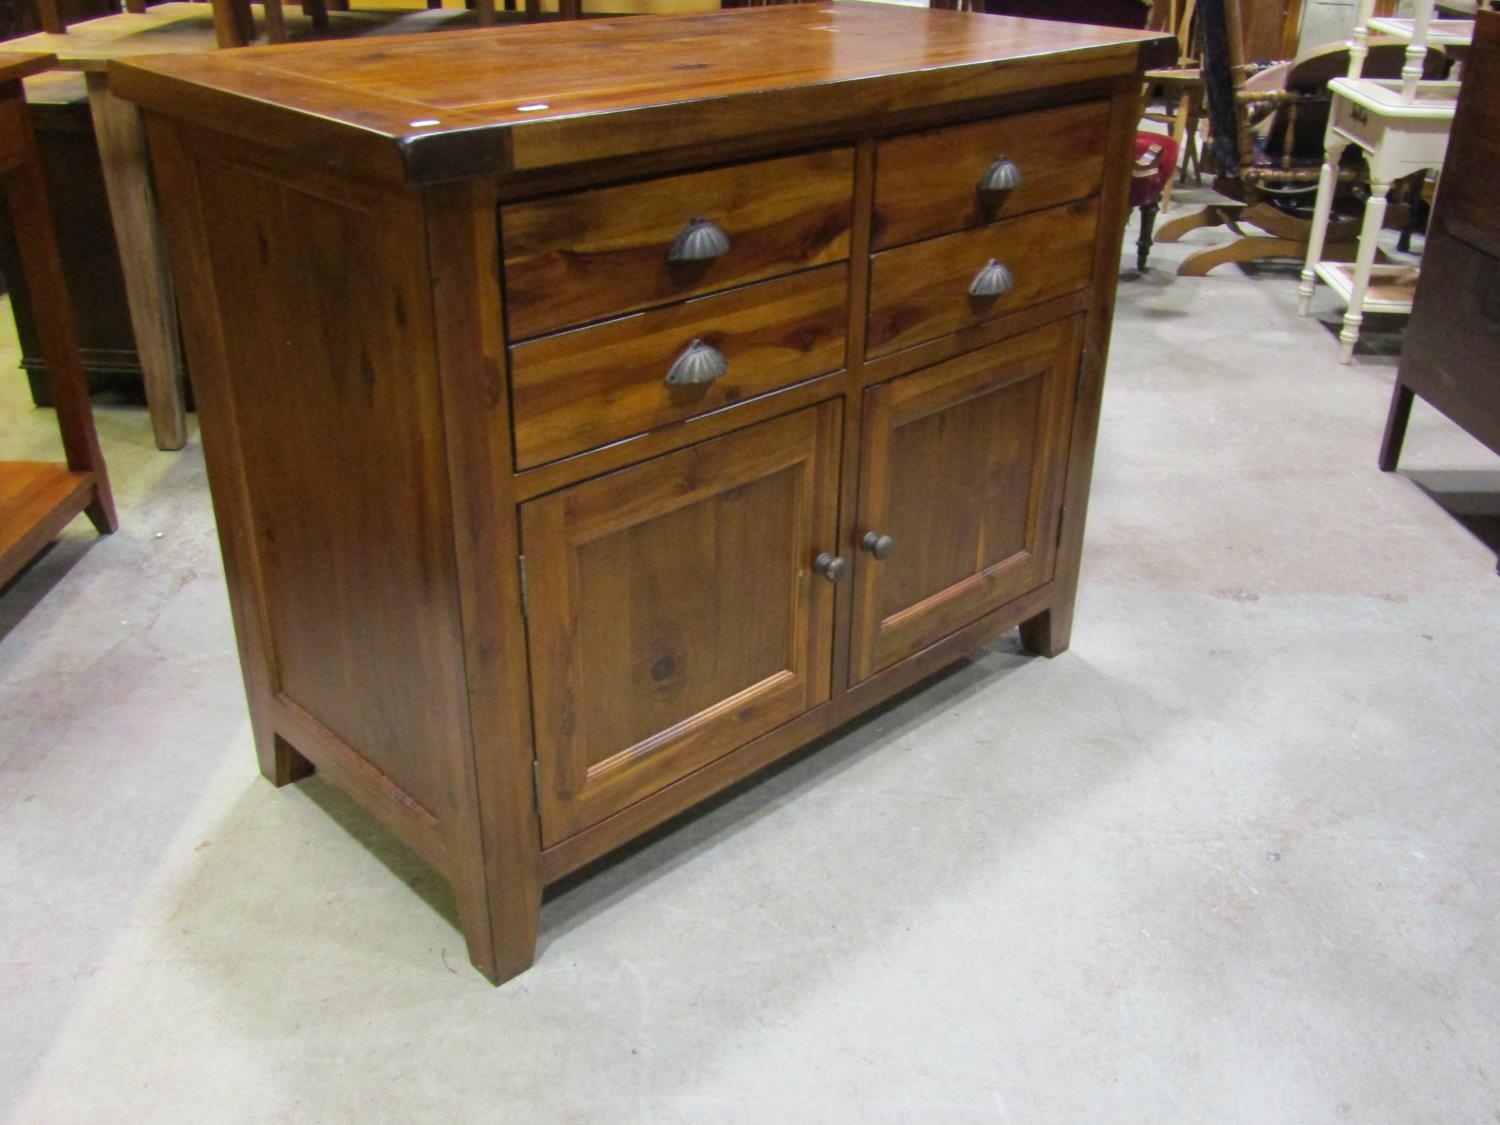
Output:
866 200 1100 357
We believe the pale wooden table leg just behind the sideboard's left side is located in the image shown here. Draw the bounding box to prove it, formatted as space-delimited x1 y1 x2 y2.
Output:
87 72 188 450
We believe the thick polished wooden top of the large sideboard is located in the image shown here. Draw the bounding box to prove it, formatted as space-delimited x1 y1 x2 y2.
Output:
110 2 1176 185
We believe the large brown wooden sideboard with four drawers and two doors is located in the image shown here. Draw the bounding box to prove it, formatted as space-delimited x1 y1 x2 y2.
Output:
111 3 1176 981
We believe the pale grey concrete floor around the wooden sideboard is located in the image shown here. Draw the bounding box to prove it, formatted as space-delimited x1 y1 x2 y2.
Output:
0 213 1500 1125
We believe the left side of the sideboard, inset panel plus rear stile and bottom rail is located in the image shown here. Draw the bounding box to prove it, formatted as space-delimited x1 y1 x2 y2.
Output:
152 120 470 873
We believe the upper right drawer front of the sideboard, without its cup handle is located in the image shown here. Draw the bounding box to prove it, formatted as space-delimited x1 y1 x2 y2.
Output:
872 102 1110 251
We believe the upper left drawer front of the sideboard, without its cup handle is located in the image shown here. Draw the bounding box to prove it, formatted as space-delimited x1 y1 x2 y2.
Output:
501 149 854 341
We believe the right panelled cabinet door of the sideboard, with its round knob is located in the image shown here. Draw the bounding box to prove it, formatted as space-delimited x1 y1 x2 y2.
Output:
851 318 1082 681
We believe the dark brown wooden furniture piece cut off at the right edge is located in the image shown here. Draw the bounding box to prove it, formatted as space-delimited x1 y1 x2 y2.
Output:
1380 12 1500 567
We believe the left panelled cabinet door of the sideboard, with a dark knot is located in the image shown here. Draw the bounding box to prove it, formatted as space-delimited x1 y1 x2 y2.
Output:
521 404 842 846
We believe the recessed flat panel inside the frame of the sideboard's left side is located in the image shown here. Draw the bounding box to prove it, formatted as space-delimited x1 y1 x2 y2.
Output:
187 143 462 818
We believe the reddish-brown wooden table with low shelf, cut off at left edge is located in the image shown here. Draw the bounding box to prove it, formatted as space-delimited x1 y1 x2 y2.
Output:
0 54 117 585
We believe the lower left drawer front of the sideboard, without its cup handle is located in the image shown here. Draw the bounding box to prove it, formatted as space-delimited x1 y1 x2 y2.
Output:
510 263 849 470
